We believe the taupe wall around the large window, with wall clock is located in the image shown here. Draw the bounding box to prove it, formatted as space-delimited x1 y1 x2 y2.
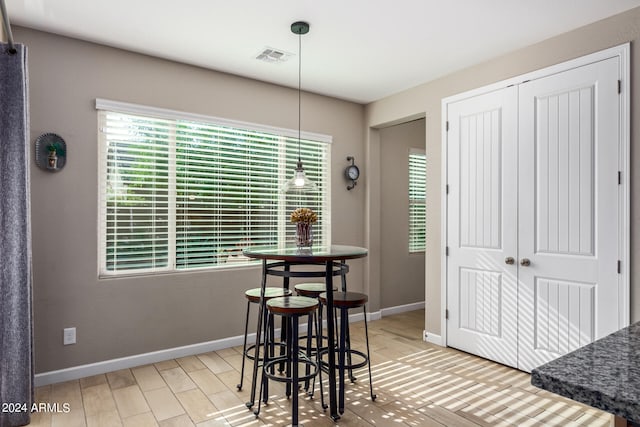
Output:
14 27 366 373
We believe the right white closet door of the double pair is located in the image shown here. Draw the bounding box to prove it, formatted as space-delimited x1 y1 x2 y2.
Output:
518 59 619 371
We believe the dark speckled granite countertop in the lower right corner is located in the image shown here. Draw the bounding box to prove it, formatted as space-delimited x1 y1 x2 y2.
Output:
531 322 640 423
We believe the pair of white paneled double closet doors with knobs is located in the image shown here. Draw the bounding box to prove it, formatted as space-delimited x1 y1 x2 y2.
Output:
446 58 624 371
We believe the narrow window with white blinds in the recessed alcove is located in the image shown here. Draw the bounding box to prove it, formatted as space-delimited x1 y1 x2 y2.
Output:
409 149 427 253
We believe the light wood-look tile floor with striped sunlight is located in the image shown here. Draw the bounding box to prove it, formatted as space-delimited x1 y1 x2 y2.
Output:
31 310 612 427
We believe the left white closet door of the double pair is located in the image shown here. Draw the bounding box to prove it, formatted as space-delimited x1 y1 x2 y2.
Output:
447 87 517 366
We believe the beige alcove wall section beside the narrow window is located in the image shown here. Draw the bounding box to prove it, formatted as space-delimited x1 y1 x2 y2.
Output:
380 119 425 308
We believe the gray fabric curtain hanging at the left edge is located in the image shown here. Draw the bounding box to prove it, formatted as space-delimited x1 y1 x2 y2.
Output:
0 43 33 427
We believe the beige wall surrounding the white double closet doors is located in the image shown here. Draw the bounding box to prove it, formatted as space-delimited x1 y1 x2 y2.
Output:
366 3 640 335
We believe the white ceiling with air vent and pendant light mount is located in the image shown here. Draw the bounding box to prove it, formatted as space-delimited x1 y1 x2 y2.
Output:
6 0 640 103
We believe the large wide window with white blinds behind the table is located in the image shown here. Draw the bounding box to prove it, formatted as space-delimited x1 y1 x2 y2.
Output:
96 100 331 276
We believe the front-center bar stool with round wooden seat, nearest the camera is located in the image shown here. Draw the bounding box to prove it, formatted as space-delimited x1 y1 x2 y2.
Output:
254 296 322 427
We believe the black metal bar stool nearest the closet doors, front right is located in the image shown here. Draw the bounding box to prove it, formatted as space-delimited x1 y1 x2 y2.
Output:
318 292 377 414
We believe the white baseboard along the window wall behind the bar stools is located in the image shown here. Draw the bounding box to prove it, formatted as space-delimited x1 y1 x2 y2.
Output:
34 302 424 387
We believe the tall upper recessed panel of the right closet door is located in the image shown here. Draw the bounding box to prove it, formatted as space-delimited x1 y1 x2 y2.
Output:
534 86 595 256
